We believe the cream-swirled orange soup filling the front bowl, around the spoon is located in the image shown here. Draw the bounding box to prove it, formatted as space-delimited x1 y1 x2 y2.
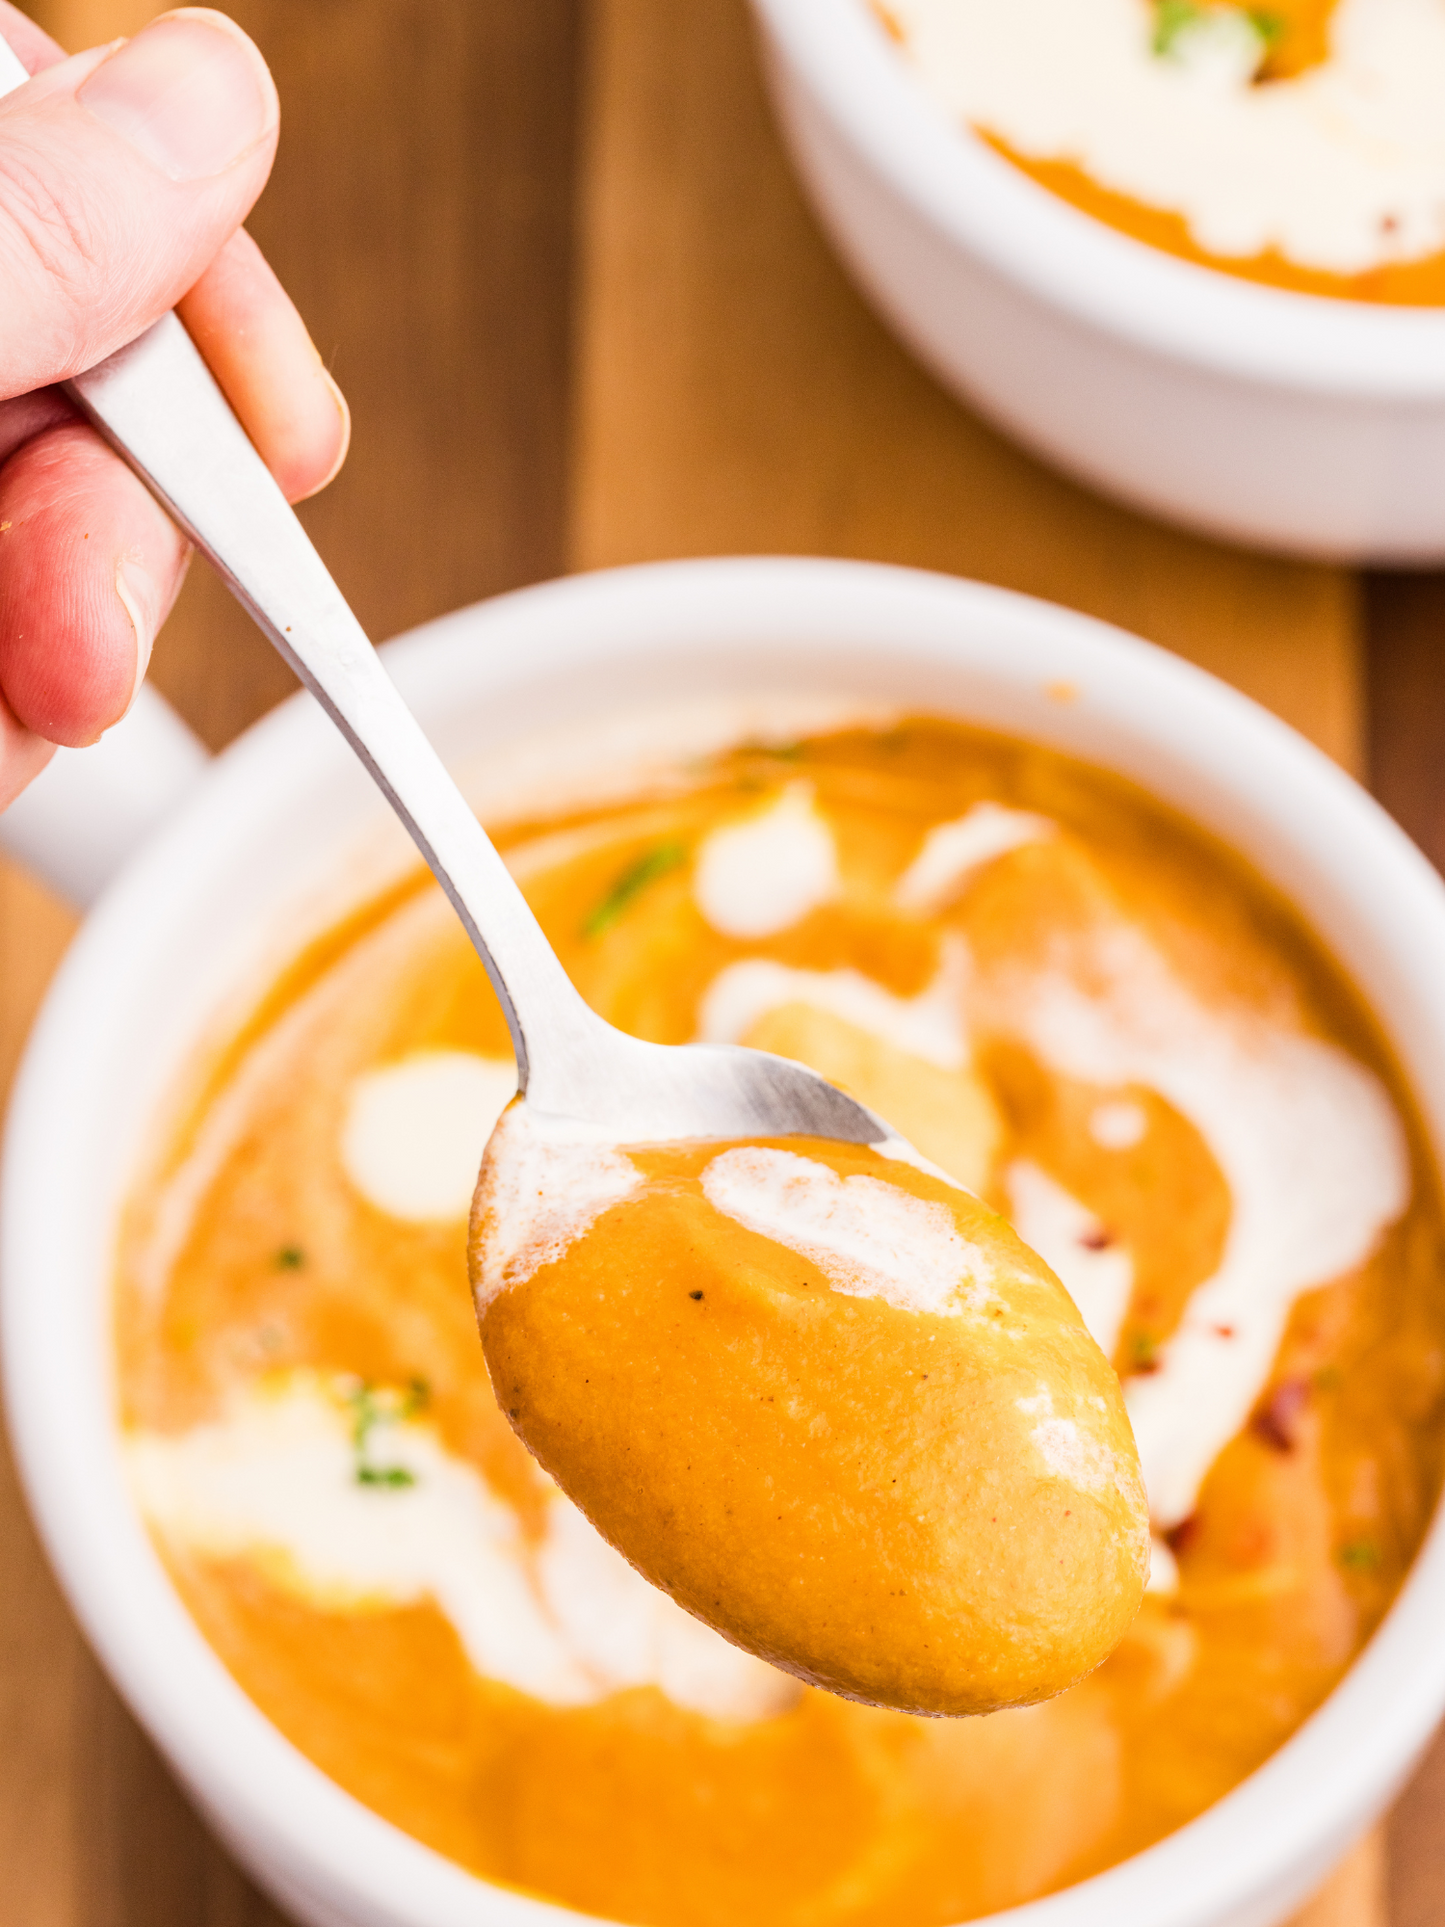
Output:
118 719 1445 1927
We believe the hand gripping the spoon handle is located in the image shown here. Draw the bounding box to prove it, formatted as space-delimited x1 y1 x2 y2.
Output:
0 0 349 807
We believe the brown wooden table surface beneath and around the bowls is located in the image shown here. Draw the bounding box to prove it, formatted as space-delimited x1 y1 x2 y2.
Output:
0 0 1445 1927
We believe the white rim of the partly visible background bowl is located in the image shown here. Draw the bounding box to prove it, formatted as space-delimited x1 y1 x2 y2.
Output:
751 0 1445 405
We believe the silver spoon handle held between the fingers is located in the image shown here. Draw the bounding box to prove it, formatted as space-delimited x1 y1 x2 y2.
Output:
0 37 601 1091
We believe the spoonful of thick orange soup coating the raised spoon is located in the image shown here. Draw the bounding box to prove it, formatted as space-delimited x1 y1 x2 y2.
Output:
472 1117 1150 1715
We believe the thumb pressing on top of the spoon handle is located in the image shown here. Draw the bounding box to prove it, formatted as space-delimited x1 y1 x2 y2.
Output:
0 8 279 399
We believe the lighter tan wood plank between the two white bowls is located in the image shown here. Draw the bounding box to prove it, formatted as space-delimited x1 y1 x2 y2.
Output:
570 0 1362 767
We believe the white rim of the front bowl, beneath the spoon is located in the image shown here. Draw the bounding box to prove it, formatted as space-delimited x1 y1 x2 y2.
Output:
0 557 1445 1927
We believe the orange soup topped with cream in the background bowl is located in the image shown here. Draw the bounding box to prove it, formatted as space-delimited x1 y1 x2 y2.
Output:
877 0 1445 306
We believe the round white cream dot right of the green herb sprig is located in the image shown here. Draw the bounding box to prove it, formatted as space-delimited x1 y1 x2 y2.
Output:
692 782 838 938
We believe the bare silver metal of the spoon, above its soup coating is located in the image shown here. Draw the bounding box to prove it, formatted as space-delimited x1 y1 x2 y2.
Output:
0 39 896 1145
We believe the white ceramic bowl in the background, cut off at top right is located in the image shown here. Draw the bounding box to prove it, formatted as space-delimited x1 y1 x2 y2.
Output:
753 0 1445 563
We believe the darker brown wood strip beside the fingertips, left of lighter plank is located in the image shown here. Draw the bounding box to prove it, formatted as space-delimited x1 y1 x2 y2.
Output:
42 0 582 748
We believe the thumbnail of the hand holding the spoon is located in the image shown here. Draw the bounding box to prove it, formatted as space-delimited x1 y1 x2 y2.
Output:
75 8 279 181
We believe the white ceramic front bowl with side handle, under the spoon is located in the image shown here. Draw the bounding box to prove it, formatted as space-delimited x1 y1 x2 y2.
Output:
0 561 1445 1927
